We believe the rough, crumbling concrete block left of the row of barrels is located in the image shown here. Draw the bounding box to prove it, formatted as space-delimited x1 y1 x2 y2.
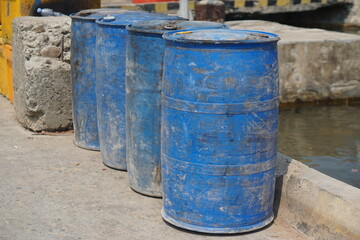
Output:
12 17 72 131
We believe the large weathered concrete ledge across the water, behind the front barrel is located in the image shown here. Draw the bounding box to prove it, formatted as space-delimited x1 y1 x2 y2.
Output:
226 20 360 103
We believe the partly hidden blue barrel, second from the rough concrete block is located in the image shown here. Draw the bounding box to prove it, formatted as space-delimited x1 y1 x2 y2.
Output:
96 12 178 170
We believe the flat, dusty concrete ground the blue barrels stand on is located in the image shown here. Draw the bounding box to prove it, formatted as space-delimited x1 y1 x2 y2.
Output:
0 96 308 240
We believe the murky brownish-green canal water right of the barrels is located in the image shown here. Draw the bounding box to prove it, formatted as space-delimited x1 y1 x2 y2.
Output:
279 105 360 188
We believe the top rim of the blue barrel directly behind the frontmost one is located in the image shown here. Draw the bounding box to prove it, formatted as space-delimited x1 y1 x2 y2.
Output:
126 18 227 35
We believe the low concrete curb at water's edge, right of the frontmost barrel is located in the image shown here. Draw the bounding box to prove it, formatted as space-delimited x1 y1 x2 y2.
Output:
276 154 360 240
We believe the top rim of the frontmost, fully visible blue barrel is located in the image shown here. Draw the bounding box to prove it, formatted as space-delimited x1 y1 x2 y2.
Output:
163 29 280 44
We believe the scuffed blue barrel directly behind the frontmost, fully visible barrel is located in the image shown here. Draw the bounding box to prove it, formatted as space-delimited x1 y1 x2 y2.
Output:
126 20 226 197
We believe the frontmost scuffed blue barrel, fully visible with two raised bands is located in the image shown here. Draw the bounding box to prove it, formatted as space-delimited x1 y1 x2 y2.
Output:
161 29 279 233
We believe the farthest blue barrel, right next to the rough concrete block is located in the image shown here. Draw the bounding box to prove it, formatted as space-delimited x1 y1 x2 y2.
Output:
71 9 127 150
